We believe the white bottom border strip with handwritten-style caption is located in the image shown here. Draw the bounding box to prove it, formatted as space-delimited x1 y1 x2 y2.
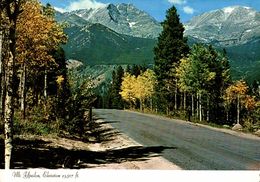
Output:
0 169 260 182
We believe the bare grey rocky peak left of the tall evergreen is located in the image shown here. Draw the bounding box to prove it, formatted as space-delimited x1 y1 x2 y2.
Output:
67 3 162 39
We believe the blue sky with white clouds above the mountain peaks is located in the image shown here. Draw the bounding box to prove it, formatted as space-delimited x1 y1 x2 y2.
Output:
41 0 260 22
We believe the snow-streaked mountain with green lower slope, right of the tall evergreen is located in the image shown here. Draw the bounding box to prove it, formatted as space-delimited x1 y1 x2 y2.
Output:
185 6 260 81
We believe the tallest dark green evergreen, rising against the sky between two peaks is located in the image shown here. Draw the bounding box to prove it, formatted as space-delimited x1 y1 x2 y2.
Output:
154 6 189 111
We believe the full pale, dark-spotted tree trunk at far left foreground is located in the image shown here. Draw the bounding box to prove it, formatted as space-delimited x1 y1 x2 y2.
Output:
3 1 21 169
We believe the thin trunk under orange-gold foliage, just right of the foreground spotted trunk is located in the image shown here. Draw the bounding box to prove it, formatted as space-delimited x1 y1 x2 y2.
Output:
20 63 26 119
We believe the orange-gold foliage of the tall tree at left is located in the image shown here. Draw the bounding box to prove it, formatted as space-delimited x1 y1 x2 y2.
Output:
17 0 66 66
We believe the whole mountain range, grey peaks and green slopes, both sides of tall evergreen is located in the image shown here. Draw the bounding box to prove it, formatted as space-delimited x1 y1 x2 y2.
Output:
56 4 260 80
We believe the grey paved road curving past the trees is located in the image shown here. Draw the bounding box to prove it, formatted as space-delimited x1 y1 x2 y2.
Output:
94 109 260 170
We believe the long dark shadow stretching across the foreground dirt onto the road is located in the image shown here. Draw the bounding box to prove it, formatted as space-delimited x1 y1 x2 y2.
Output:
0 139 175 169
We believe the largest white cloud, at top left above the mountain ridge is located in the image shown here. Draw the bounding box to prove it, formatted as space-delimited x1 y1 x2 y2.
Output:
59 0 106 12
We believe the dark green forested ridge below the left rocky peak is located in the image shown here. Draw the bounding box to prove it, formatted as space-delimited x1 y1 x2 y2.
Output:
56 12 156 65
